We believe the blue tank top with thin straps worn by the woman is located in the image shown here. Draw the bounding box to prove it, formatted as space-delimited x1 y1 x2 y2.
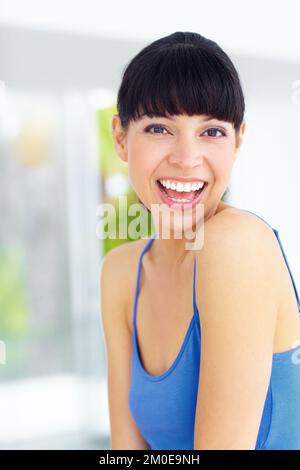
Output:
128 211 300 450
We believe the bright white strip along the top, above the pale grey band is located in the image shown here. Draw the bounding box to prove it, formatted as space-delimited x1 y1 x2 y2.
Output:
0 0 300 61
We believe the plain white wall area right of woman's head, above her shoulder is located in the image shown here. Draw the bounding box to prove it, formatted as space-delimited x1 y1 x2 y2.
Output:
230 101 300 286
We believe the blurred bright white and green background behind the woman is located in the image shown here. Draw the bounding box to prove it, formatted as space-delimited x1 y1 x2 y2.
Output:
0 0 300 449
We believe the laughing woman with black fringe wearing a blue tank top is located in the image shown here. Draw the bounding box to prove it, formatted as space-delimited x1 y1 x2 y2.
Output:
101 32 300 450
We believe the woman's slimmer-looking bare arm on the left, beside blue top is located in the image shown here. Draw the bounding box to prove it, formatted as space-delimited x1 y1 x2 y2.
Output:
99 247 148 450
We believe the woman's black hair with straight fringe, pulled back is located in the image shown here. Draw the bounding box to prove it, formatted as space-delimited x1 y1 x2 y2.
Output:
117 31 245 132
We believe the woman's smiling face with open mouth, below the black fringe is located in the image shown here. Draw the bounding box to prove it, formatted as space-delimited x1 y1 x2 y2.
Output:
112 114 245 232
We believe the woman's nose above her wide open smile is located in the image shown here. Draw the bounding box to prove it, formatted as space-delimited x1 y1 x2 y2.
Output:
168 139 205 169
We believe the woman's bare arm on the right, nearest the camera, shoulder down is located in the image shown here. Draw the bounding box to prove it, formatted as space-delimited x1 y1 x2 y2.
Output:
194 214 279 449
